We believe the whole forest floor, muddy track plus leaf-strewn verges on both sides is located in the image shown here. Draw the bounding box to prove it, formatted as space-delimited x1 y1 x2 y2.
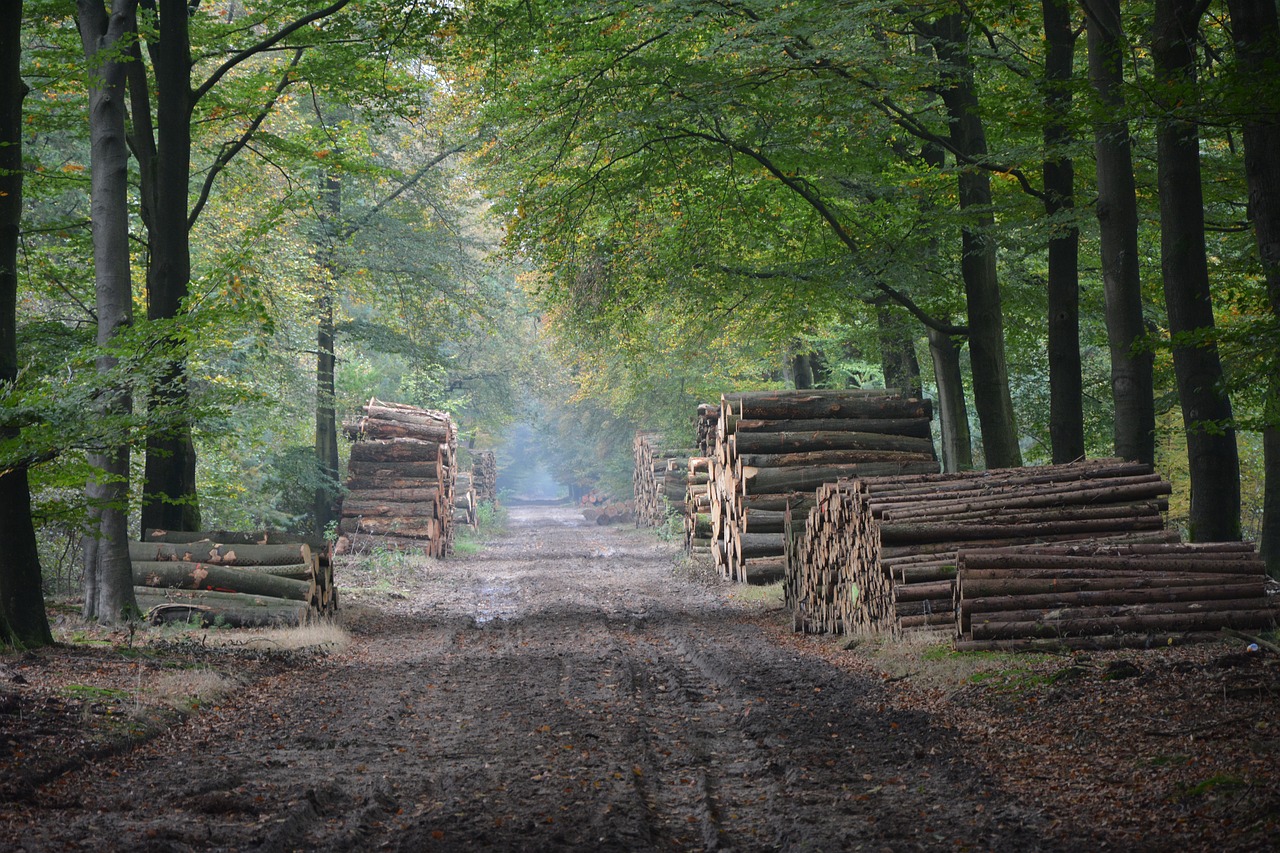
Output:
0 507 1280 850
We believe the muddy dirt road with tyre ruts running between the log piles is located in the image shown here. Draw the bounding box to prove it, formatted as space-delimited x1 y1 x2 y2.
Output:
0 507 1052 850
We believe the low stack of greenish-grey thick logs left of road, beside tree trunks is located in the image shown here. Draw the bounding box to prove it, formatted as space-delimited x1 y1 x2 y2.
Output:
129 530 338 628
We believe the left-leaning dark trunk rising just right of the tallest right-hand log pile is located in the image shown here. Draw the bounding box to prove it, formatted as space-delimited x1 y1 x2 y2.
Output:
928 14 1023 467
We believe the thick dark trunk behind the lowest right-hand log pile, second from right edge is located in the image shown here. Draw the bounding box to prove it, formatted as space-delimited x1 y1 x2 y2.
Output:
1152 0 1240 542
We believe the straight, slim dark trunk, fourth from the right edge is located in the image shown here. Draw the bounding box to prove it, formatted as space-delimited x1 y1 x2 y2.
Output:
1042 0 1084 464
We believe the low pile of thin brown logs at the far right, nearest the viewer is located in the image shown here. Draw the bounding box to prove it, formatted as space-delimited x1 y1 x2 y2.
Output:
956 542 1280 649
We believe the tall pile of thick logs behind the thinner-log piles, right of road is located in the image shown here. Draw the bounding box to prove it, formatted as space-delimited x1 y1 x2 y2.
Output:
708 389 938 583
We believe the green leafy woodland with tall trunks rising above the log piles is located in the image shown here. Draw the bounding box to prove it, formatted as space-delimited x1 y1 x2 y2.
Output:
0 0 1280 646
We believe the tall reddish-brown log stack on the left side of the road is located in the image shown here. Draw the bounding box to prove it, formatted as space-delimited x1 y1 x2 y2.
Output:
338 398 458 557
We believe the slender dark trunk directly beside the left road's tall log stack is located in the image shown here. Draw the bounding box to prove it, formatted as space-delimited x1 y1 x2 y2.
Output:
315 163 342 535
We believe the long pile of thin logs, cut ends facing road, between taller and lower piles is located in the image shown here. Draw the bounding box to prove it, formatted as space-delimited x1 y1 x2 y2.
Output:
786 460 1178 633
